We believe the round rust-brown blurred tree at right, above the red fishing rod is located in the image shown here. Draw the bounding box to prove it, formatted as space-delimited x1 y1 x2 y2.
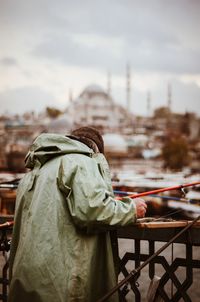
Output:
162 136 190 170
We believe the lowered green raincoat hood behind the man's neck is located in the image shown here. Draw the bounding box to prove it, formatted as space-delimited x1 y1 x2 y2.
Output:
25 133 94 169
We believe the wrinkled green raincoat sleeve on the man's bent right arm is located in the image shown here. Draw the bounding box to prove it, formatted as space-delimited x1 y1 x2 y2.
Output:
59 156 136 227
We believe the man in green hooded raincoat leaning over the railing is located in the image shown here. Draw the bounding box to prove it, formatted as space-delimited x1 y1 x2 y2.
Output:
9 127 146 302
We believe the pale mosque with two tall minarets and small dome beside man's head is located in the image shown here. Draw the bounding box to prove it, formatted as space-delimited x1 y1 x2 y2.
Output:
47 65 142 157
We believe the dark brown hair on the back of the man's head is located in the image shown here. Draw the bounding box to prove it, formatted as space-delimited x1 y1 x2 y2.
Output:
71 127 104 153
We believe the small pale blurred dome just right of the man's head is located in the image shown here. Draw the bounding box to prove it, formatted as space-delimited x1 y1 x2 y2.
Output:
103 133 127 153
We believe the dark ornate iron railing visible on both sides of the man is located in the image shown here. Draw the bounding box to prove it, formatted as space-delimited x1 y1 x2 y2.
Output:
0 219 200 302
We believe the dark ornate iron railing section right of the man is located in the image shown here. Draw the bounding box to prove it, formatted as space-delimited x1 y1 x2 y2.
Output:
118 225 200 302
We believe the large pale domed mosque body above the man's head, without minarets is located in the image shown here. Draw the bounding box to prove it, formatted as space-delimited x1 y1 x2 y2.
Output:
67 85 133 133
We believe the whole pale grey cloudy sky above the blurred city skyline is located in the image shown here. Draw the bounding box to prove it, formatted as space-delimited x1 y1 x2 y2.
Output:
0 0 200 116
